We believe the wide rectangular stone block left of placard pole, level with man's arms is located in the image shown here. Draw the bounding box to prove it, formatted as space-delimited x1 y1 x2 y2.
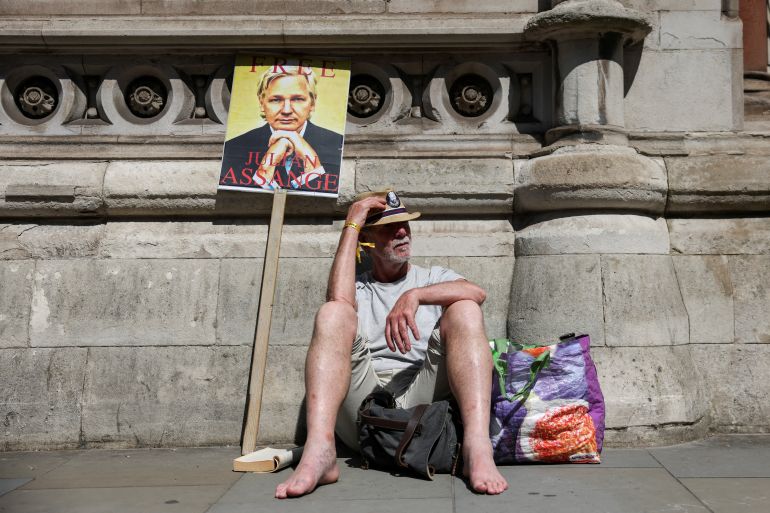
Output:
30 260 219 347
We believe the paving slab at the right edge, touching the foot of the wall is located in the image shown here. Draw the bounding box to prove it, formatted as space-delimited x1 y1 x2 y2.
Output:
650 435 770 478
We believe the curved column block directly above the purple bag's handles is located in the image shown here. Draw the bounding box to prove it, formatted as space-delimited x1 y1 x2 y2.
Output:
508 255 605 346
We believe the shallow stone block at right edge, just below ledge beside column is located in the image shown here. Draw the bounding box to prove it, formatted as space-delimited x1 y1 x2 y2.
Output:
667 217 770 255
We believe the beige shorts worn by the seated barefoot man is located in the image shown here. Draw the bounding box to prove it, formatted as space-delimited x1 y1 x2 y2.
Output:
335 327 451 451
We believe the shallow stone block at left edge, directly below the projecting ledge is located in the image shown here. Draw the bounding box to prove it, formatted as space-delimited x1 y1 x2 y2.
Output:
0 223 105 260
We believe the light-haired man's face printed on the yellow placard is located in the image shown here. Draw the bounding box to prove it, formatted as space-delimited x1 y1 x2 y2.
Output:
259 75 315 132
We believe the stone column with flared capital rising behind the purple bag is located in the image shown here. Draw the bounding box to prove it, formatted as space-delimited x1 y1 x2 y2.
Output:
508 0 708 444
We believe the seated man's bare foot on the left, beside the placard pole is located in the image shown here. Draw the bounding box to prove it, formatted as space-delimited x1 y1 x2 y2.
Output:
275 443 340 499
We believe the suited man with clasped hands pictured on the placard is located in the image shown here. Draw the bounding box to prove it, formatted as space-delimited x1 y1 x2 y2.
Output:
220 62 343 193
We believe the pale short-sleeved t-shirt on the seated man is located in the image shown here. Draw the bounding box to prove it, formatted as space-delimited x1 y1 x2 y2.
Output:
356 265 463 371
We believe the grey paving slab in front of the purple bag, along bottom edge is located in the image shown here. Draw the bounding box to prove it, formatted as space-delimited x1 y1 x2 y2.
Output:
455 465 709 513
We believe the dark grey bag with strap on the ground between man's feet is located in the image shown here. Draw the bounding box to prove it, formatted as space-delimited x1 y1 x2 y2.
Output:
358 391 461 480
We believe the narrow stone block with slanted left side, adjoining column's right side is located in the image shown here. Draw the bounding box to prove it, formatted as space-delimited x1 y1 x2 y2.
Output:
673 256 735 344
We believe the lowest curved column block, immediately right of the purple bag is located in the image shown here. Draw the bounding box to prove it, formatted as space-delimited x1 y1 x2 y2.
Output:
591 346 709 445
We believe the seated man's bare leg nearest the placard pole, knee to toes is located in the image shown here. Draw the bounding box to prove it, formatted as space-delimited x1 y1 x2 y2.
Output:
275 301 357 499
